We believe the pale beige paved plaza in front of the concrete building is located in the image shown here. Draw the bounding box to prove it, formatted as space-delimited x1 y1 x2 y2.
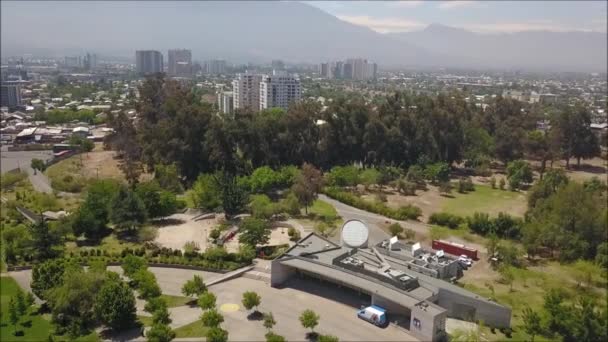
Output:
210 277 416 341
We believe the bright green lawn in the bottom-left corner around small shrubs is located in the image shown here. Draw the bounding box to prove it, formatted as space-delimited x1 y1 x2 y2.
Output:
0 277 99 342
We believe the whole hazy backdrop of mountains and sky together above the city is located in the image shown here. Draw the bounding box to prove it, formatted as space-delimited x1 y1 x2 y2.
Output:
1 1 607 72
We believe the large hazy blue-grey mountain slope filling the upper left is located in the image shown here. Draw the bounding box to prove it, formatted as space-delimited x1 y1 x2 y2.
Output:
2 1 434 65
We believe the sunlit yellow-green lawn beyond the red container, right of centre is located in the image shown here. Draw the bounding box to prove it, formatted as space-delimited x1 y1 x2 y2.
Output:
442 185 526 216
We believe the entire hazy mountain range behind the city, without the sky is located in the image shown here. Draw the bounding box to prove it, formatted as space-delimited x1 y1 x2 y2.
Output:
1 1 607 71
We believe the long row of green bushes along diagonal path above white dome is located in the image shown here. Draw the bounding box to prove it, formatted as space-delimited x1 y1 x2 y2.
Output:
323 187 422 220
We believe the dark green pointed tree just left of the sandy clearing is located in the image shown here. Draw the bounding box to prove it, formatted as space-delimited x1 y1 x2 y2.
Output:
110 186 146 232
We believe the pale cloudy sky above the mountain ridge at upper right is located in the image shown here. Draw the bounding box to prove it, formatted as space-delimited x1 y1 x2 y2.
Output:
306 0 608 33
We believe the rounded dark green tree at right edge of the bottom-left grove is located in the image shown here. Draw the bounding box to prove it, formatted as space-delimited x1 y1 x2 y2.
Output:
93 281 137 331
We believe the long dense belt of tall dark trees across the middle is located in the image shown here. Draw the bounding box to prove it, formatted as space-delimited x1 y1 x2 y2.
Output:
109 76 599 184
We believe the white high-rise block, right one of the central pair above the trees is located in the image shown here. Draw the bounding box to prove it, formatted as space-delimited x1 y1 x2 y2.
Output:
260 73 302 110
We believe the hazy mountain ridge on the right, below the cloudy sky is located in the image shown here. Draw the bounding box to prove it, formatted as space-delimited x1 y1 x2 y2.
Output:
386 24 608 71
